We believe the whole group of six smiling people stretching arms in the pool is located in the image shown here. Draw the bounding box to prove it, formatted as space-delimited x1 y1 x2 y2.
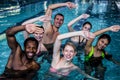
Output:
0 2 120 80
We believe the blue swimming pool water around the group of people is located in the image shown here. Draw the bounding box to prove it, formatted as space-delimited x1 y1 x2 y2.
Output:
0 0 120 80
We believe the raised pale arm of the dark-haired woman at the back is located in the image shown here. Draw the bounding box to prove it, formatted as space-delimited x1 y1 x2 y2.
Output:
68 14 90 32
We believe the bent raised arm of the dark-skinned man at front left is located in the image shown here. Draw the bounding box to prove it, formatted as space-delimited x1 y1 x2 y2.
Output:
6 24 40 51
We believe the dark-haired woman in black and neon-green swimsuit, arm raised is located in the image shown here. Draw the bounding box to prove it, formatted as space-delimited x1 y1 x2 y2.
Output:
84 25 120 80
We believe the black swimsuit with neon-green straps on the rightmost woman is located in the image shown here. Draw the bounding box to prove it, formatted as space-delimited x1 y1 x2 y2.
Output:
84 46 106 80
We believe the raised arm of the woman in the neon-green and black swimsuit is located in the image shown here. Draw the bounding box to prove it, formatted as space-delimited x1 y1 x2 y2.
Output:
85 25 120 53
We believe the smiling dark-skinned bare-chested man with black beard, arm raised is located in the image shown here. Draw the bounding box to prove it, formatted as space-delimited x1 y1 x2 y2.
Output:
0 24 41 80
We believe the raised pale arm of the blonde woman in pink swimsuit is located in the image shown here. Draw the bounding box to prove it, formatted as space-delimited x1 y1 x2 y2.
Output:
52 31 93 65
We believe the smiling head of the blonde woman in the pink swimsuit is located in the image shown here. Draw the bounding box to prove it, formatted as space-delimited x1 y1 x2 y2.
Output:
62 42 76 61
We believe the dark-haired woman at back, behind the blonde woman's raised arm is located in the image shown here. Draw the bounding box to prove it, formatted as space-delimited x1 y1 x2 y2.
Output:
68 14 92 48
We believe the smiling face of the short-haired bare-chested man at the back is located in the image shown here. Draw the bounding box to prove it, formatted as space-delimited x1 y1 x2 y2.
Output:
54 15 64 28
